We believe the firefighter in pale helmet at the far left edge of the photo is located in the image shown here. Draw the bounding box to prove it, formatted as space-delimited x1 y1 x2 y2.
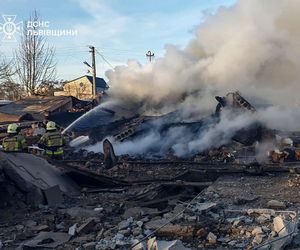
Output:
2 123 27 152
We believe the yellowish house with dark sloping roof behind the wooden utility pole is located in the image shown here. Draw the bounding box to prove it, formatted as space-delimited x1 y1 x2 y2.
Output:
54 75 109 100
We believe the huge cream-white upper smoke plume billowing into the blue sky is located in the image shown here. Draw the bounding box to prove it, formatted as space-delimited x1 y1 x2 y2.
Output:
107 0 300 112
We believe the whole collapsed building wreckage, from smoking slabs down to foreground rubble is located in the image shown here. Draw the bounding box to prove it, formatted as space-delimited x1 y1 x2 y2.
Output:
0 92 300 250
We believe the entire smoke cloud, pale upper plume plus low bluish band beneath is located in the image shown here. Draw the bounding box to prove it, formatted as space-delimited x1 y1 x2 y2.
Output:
83 0 300 156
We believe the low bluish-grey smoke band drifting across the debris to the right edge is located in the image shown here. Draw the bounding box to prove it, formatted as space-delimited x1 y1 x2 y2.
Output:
85 106 300 157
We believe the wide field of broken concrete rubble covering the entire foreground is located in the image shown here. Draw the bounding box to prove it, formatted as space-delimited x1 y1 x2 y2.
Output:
0 154 300 249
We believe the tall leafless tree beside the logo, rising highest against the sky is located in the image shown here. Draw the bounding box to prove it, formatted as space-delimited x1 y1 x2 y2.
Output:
15 11 56 95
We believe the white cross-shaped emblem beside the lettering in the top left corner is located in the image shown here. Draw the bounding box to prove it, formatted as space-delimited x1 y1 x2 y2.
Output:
0 15 23 42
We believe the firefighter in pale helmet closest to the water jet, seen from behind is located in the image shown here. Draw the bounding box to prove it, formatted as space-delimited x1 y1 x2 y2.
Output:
38 121 66 159
